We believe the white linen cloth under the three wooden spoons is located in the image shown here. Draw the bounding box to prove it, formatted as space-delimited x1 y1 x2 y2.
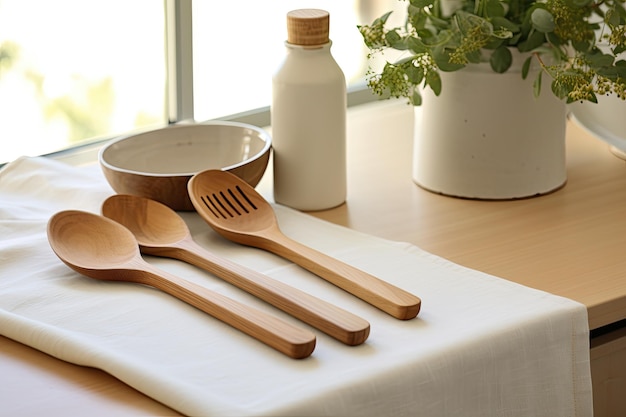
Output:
0 158 592 417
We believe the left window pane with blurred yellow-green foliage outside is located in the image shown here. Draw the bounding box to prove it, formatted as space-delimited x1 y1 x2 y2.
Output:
0 0 167 163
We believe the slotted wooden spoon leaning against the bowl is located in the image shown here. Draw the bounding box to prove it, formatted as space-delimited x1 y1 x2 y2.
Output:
187 170 421 320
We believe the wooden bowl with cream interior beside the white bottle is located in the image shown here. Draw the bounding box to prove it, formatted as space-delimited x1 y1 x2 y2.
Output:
99 122 272 211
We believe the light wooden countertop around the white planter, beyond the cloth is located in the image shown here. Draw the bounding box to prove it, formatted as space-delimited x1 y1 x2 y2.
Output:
282 102 626 329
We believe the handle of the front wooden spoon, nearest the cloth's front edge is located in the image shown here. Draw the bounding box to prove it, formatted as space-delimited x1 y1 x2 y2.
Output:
136 263 316 359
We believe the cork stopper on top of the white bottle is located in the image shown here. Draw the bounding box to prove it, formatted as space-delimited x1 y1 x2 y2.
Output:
287 9 330 46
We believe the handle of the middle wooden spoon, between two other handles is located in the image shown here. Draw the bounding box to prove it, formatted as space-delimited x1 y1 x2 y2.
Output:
168 240 370 346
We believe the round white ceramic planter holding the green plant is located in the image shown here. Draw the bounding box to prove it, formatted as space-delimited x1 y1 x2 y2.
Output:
413 54 566 200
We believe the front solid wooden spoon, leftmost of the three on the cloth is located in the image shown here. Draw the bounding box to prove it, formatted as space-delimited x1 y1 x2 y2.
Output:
48 210 316 359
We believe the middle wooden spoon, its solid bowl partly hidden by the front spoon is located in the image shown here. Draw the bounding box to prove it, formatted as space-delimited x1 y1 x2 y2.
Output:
102 195 370 345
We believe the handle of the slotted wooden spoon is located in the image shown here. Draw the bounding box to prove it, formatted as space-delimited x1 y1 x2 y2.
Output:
259 228 422 320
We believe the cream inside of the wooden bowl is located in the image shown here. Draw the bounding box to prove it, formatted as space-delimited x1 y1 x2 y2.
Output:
101 123 270 175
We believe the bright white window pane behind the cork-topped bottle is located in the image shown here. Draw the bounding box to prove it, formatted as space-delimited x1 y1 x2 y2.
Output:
193 0 382 120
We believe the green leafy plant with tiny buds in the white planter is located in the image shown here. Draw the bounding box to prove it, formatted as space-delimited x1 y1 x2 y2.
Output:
358 0 626 105
